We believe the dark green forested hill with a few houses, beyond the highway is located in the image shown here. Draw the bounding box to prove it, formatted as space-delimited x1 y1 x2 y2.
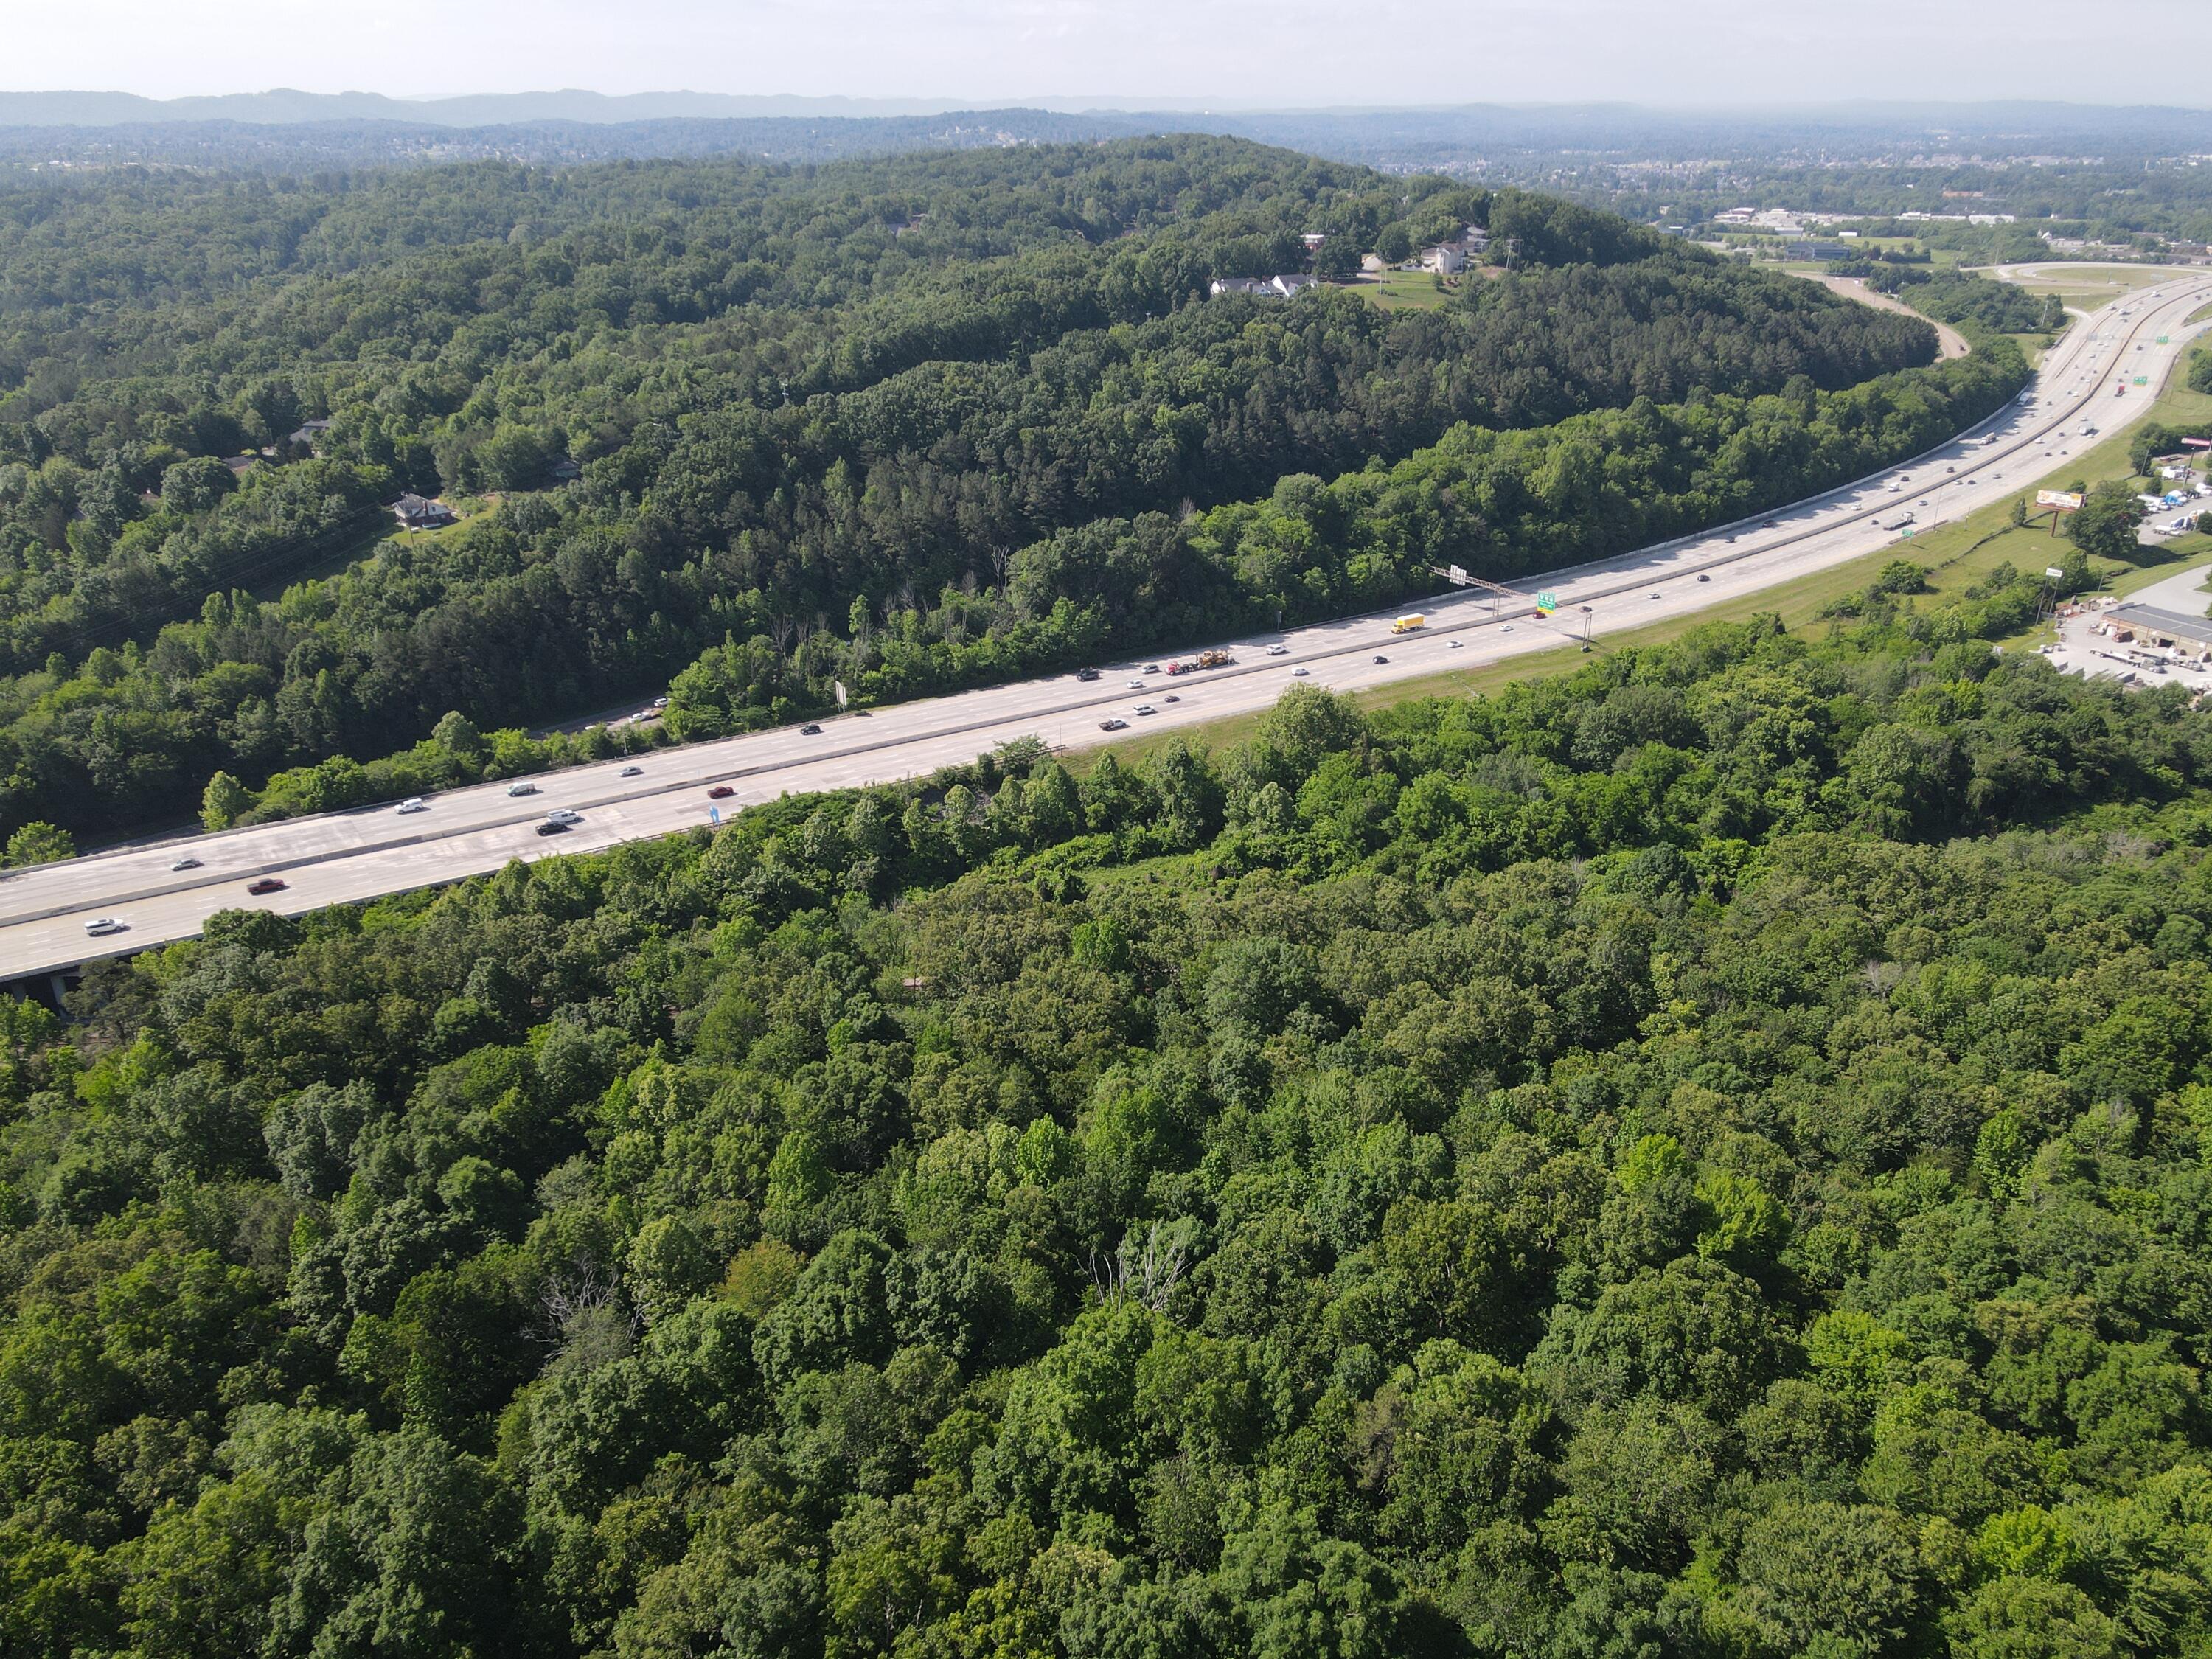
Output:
0 139 1973 849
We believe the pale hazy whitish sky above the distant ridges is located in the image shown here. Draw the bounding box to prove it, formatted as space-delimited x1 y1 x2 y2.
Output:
0 0 2212 106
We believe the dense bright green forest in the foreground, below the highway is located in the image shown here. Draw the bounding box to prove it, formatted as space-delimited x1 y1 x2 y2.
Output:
13 593 2212 1659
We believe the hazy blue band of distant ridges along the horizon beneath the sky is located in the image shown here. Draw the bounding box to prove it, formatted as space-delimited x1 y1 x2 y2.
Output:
0 88 2212 180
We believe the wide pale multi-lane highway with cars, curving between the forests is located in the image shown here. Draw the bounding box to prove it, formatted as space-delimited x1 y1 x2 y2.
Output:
0 270 2212 980
